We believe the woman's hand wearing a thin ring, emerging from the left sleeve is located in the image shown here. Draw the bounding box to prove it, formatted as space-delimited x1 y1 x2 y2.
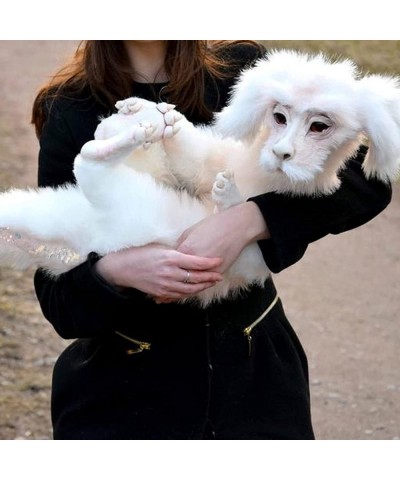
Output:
95 244 222 302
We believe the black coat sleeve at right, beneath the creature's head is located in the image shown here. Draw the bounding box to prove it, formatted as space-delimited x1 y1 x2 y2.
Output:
249 147 392 273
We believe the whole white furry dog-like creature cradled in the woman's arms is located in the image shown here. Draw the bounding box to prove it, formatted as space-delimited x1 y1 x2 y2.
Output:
0 51 400 306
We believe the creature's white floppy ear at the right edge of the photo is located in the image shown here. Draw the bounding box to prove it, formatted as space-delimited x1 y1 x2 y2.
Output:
359 75 400 181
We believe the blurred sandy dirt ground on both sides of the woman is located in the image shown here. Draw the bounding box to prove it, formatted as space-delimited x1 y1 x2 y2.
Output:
0 41 400 439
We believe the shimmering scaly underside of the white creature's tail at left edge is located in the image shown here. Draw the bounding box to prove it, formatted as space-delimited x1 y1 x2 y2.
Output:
0 227 84 275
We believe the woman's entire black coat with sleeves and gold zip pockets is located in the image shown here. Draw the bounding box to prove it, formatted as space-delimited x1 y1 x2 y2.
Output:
35 41 391 439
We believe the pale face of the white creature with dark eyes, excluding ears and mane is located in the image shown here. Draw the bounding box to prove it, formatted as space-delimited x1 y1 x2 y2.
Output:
260 99 359 182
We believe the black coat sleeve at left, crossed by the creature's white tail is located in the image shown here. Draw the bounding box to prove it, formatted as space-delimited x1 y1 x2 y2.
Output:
34 99 145 338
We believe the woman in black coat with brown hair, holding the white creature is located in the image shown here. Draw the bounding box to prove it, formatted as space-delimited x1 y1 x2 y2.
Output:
32 40 391 439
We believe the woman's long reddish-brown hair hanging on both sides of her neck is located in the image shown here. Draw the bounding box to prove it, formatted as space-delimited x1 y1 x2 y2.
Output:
31 40 262 136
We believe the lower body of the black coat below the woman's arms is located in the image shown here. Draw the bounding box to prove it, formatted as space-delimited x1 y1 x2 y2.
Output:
52 281 313 440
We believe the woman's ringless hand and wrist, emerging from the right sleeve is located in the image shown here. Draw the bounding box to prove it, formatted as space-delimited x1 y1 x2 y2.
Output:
177 202 269 273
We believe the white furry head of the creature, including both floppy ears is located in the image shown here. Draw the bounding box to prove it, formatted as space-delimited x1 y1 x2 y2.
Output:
216 50 400 184
